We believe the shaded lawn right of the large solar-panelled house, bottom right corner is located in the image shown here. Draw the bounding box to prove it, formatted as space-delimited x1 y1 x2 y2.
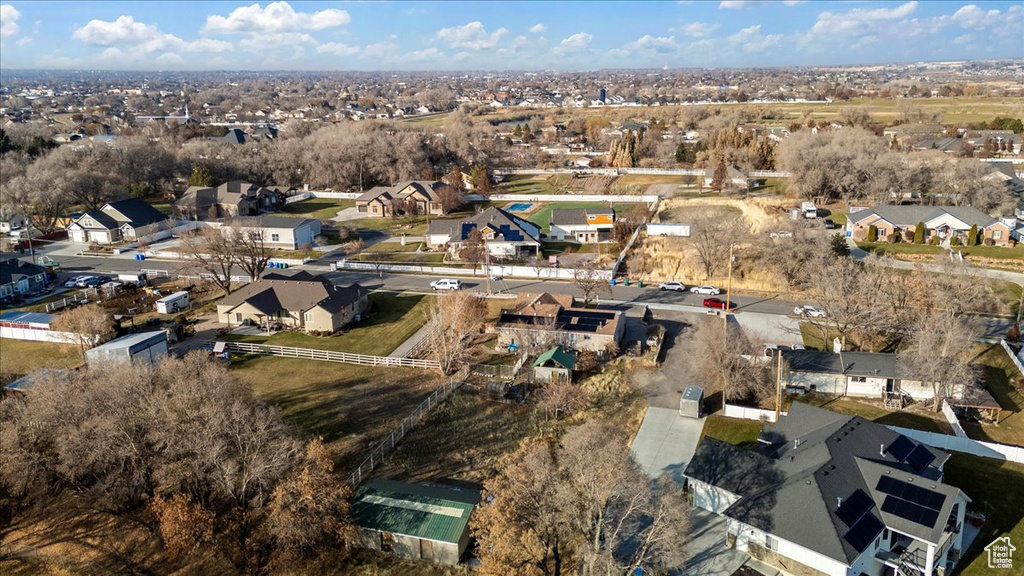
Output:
942 452 1024 576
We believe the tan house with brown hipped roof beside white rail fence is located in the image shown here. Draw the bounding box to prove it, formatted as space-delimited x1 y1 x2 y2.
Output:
217 272 370 333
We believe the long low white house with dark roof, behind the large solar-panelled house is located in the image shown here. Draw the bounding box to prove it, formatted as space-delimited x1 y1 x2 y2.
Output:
781 349 965 402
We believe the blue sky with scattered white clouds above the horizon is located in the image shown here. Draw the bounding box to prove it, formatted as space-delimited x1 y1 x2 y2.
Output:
0 0 1024 71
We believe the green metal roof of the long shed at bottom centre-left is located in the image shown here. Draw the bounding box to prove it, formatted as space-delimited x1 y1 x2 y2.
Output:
349 480 480 544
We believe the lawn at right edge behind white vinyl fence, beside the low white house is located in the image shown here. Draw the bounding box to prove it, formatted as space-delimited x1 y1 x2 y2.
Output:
961 344 1024 446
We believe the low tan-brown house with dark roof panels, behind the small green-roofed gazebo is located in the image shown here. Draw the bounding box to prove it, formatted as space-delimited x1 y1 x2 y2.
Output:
496 292 626 354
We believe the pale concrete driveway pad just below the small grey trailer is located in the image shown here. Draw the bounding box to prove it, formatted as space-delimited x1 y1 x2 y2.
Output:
631 407 703 486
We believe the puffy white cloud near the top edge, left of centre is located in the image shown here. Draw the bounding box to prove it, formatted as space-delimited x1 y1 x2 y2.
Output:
204 2 352 34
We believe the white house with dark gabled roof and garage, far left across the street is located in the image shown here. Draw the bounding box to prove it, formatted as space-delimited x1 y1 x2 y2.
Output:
68 198 167 244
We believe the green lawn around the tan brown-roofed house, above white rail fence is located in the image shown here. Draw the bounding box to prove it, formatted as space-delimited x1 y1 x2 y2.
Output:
223 292 430 354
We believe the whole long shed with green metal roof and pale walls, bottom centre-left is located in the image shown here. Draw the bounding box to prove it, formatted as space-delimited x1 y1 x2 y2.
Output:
349 480 480 566
